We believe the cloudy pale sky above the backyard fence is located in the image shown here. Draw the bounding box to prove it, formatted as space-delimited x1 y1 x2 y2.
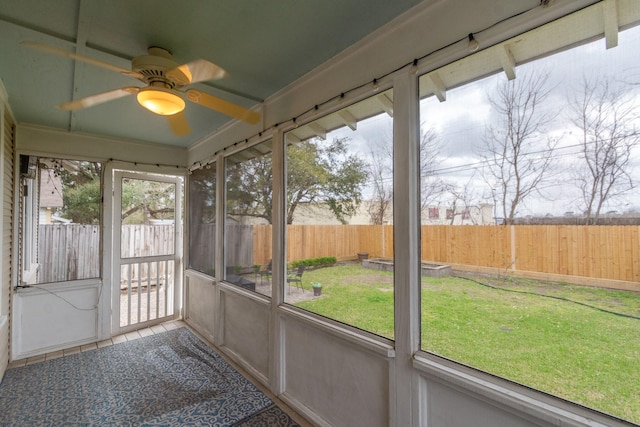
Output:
328 26 640 216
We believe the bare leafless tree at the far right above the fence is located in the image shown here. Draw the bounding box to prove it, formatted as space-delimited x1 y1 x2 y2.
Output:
570 78 640 224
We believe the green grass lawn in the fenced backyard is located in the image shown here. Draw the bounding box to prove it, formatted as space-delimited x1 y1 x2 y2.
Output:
296 265 640 423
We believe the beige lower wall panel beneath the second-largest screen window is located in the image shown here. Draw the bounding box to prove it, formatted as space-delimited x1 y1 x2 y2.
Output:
280 310 396 427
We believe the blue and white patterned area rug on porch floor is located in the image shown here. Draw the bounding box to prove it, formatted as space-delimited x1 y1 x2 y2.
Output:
0 328 298 426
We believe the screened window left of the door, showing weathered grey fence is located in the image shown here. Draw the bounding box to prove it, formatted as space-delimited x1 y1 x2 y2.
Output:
22 156 102 283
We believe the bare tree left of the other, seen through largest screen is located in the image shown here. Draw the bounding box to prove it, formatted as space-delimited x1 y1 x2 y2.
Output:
480 73 558 224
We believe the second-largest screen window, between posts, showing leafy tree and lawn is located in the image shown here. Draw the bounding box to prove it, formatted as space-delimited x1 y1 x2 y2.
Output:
285 91 394 338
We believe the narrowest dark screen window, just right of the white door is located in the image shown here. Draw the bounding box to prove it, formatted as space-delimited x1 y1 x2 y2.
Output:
189 163 216 276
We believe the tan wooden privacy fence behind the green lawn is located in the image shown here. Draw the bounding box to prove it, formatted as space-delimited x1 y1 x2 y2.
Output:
253 225 640 282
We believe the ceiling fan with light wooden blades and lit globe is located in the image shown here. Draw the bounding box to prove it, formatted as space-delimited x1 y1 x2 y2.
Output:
20 41 260 136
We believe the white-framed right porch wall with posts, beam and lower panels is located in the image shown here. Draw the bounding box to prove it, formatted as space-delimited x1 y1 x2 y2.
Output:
186 0 625 427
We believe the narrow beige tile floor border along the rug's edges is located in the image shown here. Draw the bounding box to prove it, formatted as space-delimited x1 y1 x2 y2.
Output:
8 320 312 427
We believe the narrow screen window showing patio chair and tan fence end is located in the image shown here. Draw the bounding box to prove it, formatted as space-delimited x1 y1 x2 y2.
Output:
224 140 273 296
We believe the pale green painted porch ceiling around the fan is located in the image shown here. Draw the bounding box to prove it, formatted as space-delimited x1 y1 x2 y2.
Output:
0 0 420 147
